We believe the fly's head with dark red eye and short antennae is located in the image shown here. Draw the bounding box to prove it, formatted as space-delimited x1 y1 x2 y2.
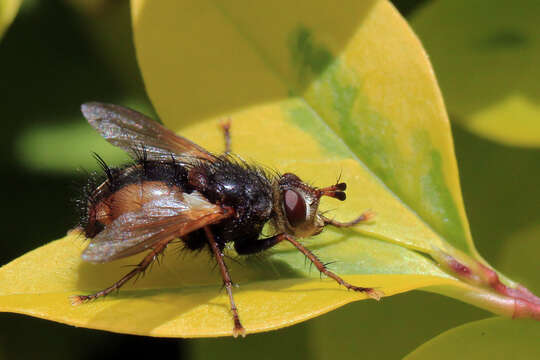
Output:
274 173 347 237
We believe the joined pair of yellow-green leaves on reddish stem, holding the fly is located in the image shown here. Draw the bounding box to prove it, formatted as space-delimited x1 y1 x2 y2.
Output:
0 0 539 337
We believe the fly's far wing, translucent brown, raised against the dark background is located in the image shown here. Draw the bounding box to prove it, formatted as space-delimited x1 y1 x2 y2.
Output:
81 102 214 163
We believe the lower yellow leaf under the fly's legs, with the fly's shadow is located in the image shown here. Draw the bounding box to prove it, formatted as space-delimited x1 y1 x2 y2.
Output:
0 234 456 337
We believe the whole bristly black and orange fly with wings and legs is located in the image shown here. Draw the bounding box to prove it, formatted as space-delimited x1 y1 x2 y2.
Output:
72 103 382 337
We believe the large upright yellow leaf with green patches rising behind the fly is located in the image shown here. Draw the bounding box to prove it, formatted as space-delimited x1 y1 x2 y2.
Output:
132 1 474 253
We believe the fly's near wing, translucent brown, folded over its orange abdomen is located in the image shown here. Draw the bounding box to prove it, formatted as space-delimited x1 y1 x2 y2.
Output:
82 192 231 263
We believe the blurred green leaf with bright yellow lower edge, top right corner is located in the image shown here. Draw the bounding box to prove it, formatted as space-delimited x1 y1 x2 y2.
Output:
411 0 540 147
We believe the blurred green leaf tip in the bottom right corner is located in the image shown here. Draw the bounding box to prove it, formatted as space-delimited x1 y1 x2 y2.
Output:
405 318 540 360
